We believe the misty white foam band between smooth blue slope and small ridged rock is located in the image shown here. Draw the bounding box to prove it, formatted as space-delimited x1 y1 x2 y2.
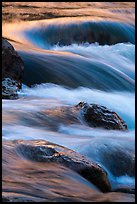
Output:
17 83 135 129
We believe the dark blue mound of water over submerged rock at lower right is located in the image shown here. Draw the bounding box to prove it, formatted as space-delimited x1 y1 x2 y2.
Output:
98 145 135 178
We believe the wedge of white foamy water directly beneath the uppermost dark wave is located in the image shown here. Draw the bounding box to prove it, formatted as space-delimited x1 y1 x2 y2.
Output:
52 43 135 79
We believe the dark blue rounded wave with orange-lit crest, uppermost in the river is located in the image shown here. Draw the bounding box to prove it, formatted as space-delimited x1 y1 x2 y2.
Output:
23 18 135 49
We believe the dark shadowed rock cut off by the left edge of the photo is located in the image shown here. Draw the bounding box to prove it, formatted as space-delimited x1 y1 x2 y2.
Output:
2 38 24 99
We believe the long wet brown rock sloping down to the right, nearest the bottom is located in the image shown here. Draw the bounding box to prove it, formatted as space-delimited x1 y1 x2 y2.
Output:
16 141 111 192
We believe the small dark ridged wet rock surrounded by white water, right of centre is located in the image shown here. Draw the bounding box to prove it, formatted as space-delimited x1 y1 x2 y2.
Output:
76 102 127 130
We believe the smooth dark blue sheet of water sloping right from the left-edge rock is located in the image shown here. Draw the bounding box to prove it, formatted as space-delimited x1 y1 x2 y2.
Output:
19 45 135 92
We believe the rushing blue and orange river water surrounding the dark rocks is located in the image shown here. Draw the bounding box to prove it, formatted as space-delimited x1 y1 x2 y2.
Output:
2 2 135 202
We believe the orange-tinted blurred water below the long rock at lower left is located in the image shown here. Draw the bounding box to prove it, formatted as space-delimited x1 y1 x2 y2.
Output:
2 140 135 202
